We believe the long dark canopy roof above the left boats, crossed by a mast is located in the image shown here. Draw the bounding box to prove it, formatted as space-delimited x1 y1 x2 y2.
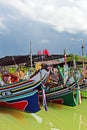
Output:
0 54 64 66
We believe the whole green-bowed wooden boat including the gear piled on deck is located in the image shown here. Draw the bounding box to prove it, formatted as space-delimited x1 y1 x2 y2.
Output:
40 63 81 106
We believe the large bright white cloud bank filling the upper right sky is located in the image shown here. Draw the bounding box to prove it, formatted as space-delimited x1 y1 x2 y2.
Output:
0 0 87 33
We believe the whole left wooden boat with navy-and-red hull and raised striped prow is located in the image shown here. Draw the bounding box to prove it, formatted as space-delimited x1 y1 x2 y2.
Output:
0 70 48 113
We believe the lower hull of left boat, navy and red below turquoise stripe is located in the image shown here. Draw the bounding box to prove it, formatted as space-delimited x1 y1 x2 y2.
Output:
0 90 40 113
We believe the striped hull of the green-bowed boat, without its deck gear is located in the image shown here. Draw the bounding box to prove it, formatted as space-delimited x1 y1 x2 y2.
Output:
40 82 81 106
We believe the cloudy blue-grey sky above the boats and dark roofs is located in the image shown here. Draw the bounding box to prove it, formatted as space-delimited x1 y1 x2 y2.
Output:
0 0 87 57
